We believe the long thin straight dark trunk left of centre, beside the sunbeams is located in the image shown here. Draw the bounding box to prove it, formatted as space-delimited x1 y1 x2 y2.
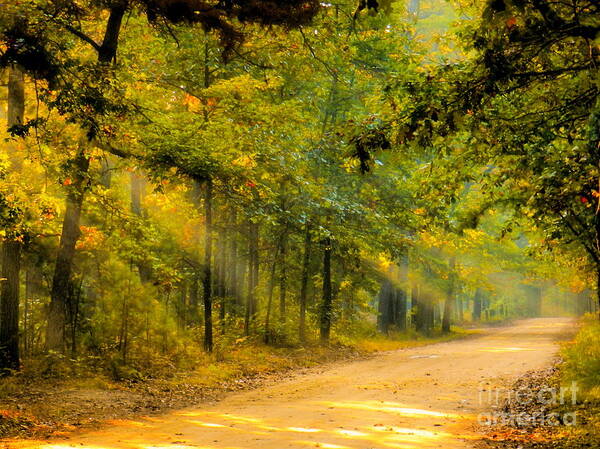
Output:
202 179 213 352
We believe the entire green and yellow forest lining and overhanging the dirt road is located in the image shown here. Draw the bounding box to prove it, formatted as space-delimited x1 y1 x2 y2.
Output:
0 0 600 447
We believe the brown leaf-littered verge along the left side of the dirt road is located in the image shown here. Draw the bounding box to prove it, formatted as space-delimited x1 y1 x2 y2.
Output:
0 329 472 438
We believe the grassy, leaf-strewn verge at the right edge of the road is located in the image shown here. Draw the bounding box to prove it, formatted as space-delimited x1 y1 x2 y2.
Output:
478 316 600 449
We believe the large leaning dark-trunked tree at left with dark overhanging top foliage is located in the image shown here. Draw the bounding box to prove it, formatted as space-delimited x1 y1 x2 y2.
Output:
0 0 319 351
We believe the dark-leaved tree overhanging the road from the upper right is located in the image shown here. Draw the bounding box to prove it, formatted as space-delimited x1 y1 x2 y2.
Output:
378 0 600 312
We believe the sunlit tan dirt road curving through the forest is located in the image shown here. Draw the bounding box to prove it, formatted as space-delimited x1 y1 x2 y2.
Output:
11 318 573 449
